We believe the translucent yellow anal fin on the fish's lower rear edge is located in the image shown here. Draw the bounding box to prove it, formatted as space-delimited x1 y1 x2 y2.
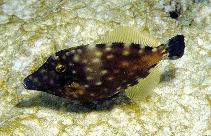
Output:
125 64 161 101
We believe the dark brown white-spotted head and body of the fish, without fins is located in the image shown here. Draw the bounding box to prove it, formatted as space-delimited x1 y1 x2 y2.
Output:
24 43 165 101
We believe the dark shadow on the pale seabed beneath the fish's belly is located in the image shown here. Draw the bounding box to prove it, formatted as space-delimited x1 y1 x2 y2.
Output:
15 93 131 113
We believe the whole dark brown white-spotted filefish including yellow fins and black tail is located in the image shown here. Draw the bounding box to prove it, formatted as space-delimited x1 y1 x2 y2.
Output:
23 27 185 101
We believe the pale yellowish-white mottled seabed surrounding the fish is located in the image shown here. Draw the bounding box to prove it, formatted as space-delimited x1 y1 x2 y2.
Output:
0 0 211 136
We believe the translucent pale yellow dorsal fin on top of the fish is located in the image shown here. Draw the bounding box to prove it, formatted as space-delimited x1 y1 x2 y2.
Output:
96 26 160 47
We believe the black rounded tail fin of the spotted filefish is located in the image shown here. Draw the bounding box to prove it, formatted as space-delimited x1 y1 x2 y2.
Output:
167 35 185 60
